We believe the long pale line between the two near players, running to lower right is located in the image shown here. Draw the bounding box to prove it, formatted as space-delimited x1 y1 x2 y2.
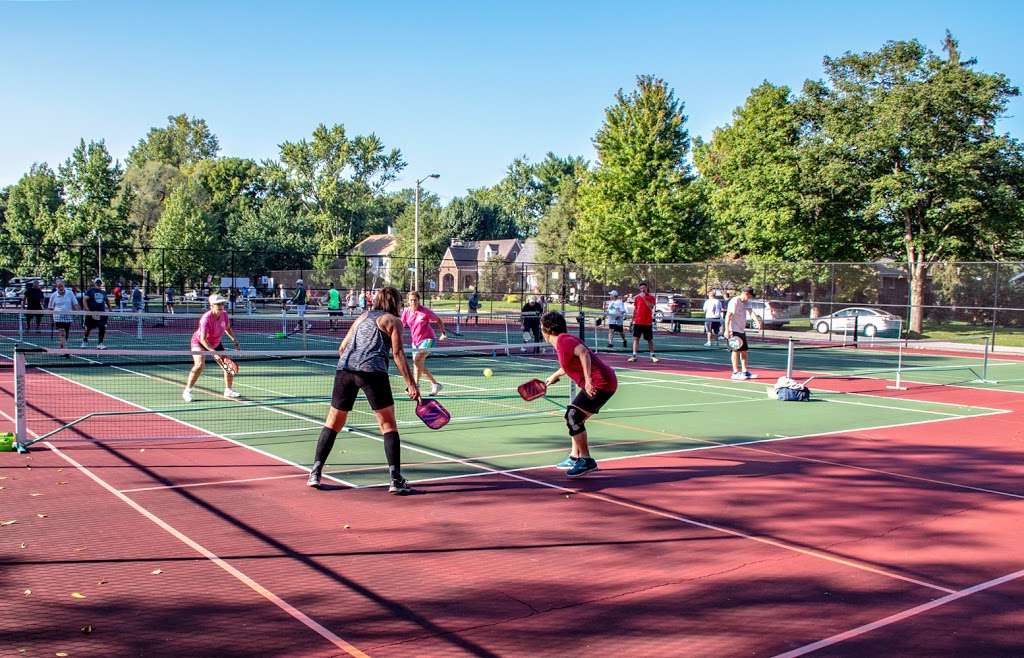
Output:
348 432 953 594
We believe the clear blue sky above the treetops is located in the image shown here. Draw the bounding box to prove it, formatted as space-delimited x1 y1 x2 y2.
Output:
0 0 1024 201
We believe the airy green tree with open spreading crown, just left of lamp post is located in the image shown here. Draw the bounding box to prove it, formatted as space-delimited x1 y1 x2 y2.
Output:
281 124 406 270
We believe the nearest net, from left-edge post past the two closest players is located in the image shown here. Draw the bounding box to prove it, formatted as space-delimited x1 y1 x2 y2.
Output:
13 343 573 446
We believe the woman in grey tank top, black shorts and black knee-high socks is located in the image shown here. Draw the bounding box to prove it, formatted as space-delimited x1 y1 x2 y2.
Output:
306 288 420 494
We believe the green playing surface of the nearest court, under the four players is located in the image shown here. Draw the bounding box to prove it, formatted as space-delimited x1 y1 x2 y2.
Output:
30 353 999 486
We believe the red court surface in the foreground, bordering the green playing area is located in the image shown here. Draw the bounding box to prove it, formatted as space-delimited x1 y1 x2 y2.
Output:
0 362 1024 657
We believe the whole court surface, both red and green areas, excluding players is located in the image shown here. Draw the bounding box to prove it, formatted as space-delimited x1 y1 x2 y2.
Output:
0 339 1024 656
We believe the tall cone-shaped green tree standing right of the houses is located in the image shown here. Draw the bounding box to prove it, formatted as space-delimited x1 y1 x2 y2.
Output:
572 76 707 265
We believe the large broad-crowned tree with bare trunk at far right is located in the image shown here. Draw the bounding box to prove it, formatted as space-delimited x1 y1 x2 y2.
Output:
804 34 1024 334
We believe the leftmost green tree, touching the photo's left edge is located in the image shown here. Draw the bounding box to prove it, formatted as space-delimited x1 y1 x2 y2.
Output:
0 164 62 274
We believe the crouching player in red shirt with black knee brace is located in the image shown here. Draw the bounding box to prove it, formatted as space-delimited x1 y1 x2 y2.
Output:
541 311 618 478
